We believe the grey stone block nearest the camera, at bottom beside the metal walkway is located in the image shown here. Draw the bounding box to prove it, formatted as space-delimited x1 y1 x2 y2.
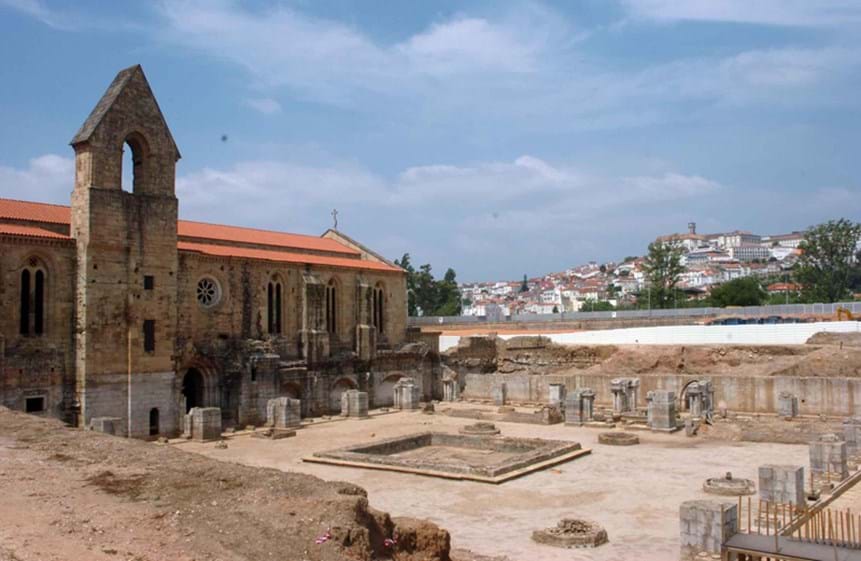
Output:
679 500 738 553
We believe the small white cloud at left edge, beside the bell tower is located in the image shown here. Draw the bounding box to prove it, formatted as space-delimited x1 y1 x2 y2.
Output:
0 154 75 204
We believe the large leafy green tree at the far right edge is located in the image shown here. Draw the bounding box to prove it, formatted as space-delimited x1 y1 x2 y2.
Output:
795 218 861 302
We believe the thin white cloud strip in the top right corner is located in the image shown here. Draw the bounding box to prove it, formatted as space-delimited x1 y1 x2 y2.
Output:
622 0 861 27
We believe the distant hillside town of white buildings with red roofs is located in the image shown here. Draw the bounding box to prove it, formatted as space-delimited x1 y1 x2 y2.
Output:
460 222 804 317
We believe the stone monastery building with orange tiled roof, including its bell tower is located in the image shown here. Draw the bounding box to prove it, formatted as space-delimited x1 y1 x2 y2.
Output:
0 66 439 438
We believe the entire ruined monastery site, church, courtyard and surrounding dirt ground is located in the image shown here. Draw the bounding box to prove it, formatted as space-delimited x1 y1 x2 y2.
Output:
5 62 861 561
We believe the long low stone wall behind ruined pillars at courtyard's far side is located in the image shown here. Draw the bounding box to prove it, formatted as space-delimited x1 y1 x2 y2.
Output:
462 373 861 416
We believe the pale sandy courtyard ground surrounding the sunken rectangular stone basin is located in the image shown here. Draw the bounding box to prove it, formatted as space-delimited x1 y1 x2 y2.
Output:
185 404 808 561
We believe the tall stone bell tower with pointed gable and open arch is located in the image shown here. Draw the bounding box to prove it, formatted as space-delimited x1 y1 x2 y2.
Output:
71 65 180 436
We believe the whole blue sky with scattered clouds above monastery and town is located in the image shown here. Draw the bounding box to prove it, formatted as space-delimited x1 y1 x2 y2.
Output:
0 0 861 280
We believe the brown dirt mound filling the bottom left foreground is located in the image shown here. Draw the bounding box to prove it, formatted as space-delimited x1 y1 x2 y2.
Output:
0 408 449 561
